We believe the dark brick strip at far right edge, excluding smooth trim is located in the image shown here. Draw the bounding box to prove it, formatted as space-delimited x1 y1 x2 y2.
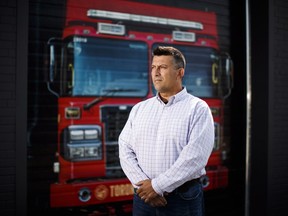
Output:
268 0 288 216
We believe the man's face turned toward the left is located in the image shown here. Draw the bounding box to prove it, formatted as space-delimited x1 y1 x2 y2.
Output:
151 56 183 95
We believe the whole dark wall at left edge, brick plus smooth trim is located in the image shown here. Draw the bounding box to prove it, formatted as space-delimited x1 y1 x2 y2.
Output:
0 0 28 216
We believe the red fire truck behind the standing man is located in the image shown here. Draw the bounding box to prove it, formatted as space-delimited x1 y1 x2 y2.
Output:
48 0 232 213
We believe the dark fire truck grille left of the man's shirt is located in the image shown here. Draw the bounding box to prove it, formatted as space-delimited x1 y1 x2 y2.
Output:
101 105 132 177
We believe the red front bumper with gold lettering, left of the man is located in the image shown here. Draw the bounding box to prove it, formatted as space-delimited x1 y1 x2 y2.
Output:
50 179 134 208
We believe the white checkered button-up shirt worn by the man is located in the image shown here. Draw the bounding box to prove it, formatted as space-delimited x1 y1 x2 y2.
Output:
119 88 214 195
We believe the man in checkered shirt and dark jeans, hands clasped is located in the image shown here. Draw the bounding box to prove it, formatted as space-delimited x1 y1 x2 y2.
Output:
119 47 214 216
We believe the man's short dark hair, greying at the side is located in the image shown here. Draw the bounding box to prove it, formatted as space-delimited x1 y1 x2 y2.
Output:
153 46 186 69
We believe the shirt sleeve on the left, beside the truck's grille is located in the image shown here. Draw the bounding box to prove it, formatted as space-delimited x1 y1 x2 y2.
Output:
118 104 148 187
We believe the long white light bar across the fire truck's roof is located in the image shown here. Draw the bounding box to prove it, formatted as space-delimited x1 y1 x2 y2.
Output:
87 9 203 30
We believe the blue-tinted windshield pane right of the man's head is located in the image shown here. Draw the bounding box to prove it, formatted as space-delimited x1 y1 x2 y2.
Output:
153 44 222 98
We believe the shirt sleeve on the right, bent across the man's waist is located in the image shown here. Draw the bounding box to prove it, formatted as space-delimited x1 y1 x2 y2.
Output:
152 101 214 195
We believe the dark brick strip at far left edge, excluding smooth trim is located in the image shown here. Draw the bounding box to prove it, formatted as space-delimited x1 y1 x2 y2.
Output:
0 0 17 215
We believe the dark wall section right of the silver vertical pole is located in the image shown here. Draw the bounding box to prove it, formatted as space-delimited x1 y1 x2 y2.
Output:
249 0 288 216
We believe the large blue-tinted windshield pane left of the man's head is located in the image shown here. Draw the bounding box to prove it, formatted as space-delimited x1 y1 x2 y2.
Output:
61 37 148 97
